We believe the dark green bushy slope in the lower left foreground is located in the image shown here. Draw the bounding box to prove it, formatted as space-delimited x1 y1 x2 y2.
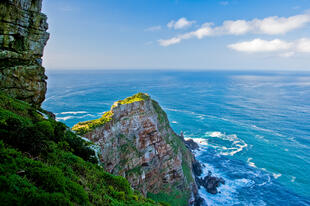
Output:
0 92 158 206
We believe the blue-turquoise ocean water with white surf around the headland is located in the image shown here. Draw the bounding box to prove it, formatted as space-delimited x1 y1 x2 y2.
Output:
43 70 310 205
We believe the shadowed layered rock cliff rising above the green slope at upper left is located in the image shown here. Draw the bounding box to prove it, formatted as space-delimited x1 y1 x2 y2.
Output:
0 0 49 106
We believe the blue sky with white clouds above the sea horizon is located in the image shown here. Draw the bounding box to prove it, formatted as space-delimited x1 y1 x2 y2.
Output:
43 0 310 71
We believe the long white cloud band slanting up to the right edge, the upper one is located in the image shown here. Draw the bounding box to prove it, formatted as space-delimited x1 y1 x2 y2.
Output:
159 14 310 46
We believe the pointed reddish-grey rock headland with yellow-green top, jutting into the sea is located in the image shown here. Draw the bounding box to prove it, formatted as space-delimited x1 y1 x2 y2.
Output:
73 93 196 205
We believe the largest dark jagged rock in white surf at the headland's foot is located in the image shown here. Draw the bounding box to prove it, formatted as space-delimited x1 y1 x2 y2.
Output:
196 171 225 194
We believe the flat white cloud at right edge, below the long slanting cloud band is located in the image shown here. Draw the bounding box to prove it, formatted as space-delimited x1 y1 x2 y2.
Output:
228 38 310 57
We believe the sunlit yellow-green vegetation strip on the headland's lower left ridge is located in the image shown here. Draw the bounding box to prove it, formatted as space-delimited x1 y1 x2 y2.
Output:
72 111 113 135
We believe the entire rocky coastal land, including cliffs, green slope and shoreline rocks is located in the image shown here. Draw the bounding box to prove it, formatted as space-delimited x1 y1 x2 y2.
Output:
0 0 224 206
